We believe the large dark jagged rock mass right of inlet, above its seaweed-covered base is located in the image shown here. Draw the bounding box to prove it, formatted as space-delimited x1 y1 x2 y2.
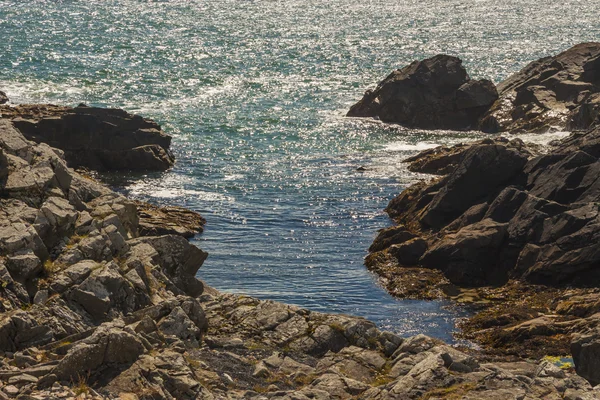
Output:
368 128 600 285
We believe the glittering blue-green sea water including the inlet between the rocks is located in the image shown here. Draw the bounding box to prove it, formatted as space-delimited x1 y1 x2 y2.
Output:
0 0 600 340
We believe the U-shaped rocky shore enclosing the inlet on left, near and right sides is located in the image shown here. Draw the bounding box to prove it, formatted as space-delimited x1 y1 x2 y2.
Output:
0 40 600 400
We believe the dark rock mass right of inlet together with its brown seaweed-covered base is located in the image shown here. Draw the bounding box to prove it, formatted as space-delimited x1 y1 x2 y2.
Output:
365 127 600 384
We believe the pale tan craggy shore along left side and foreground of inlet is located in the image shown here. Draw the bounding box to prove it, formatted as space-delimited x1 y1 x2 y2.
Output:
0 100 598 399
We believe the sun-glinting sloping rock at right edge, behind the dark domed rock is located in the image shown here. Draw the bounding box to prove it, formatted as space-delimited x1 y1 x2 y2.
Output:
481 43 600 133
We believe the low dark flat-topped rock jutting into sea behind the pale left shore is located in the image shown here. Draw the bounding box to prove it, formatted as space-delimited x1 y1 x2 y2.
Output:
0 104 174 171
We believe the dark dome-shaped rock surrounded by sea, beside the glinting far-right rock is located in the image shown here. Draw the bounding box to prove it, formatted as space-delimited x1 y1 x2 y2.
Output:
347 55 498 130
